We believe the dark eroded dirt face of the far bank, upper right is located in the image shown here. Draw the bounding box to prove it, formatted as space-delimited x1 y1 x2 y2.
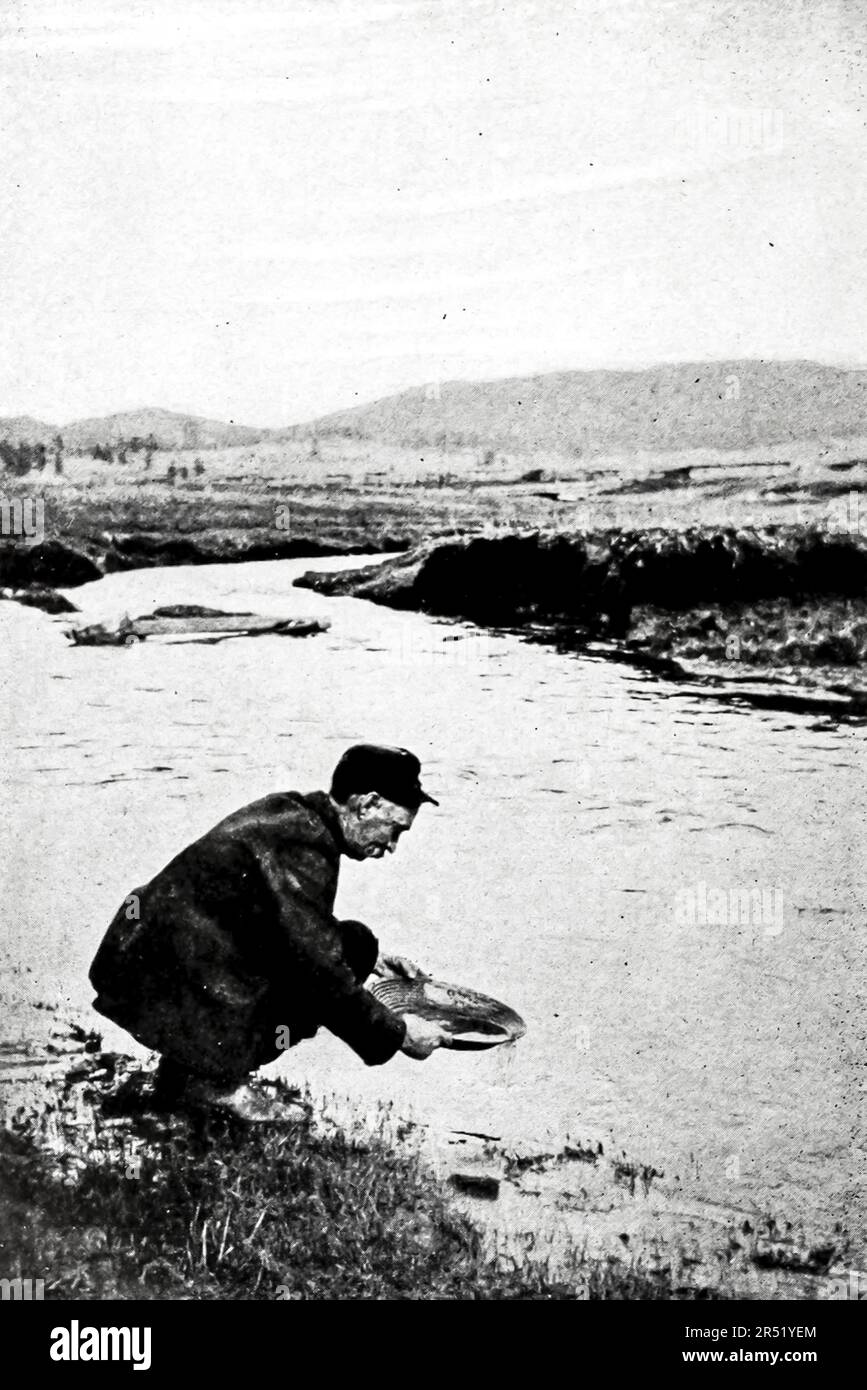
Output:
299 527 867 619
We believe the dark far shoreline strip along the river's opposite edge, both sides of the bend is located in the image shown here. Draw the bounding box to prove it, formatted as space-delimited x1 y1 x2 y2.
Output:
0 499 867 719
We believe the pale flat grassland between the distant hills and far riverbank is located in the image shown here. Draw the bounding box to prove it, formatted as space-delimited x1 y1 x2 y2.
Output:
3 436 863 559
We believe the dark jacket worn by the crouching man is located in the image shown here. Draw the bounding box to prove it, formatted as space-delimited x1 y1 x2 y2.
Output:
90 792 406 1079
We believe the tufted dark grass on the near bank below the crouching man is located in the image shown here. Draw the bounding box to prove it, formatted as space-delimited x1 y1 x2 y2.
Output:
0 1061 718 1300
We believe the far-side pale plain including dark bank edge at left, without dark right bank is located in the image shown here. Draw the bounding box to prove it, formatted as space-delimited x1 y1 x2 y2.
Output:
0 436 867 587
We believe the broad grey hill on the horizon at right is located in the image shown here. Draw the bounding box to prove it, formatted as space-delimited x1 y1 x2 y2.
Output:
301 360 867 455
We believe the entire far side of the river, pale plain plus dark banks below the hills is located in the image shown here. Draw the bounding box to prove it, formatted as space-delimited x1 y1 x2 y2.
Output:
0 438 867 705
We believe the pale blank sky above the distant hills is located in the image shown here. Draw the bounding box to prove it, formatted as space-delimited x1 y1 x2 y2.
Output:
0 0 867 425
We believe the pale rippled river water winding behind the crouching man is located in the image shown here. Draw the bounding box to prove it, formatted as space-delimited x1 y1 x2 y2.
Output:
0 560 867 1268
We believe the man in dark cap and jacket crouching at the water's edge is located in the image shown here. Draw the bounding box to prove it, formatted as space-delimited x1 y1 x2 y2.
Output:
90 744 445 1122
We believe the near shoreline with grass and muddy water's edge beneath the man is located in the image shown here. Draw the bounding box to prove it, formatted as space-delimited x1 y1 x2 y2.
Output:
0 1045 845 1301
